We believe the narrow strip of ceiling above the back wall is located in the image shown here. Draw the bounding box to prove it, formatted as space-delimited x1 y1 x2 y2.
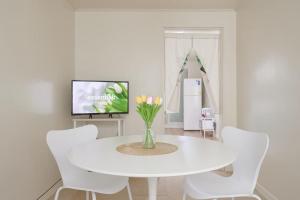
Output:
69 0 237 9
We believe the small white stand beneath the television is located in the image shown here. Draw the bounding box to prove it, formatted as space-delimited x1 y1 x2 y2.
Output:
73 118 125 136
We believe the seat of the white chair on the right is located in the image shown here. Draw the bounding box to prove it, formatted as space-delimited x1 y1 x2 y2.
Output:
184 172 252 199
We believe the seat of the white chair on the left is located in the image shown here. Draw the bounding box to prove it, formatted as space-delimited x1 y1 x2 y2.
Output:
64 170 128 194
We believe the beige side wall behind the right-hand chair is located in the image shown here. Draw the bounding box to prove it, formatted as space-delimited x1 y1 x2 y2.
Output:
237 0 300 200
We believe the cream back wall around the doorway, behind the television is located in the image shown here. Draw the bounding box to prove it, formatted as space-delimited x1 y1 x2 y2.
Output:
75 10 236 133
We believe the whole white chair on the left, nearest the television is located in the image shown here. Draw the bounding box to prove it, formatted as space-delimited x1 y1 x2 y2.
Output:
47 125 132 200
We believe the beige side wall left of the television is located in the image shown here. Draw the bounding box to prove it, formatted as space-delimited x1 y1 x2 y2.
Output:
0 0 74 200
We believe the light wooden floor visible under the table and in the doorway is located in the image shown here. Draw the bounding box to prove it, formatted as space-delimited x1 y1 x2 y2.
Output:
49 129 258 200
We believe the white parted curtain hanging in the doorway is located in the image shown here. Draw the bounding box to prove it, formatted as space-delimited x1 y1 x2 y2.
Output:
165 36 220 113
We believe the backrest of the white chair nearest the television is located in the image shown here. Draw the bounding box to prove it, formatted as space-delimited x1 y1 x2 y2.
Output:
47 125 98 185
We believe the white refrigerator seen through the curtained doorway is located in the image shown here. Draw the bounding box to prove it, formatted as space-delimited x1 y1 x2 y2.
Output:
183 79 202 130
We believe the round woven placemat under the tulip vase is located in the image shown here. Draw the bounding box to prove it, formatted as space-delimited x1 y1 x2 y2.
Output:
116 142 178 156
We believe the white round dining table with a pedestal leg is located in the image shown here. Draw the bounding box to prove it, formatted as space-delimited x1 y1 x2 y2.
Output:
68 135 237 200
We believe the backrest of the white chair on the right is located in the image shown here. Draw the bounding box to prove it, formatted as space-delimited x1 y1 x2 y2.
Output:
222 127 269 192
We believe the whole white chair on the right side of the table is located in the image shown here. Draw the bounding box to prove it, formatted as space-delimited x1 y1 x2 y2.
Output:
183 127 269 200
